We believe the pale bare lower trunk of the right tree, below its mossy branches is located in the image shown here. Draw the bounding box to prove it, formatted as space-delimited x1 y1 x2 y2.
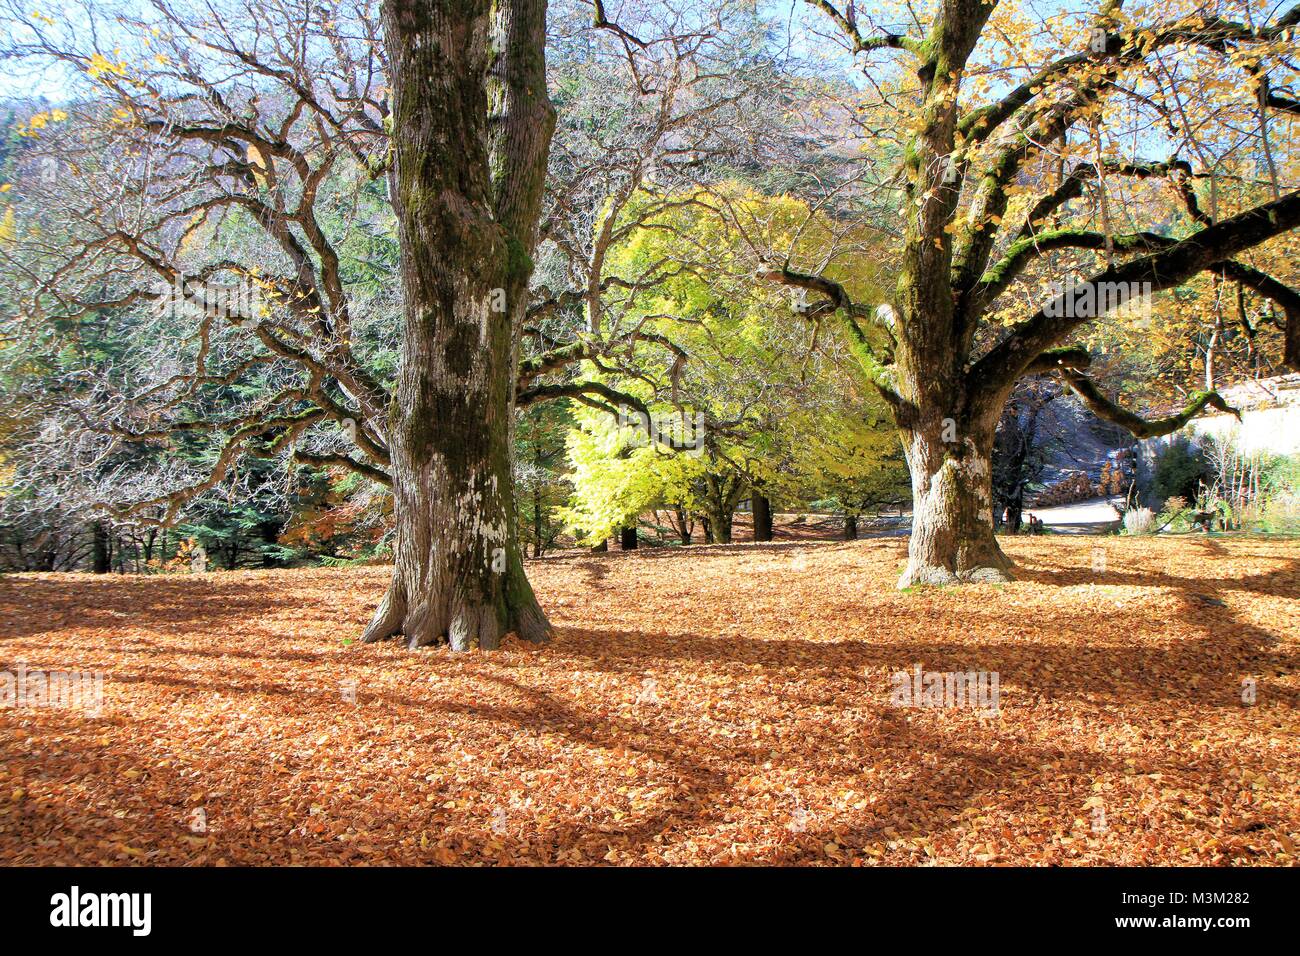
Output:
898 424 1011 588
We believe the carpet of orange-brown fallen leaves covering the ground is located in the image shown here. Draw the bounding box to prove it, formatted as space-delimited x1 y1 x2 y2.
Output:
0 537 1300 865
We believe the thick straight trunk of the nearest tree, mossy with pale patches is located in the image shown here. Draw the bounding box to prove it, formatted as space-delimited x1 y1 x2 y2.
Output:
364 0 554 650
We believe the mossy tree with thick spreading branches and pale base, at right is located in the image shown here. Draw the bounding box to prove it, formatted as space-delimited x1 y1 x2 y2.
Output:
761 0 1300 587
